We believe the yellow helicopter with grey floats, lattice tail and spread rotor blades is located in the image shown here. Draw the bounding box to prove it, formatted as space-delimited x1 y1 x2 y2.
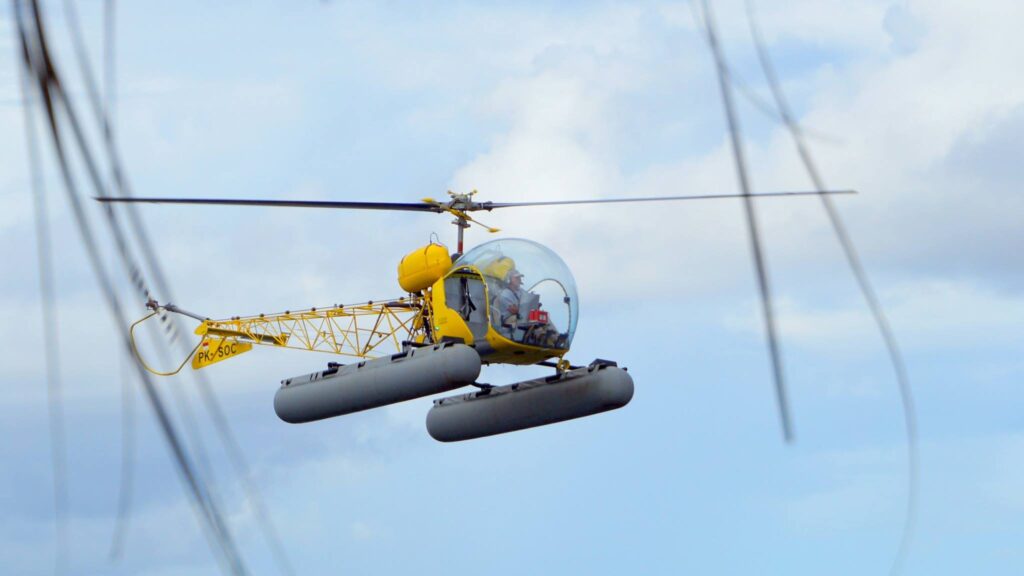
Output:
96 190 855 442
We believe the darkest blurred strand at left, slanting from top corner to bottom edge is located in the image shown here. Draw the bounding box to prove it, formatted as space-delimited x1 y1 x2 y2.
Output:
12 0 246 574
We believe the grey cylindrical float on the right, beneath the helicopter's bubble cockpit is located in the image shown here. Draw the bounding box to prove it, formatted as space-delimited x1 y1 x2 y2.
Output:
427 361 633 442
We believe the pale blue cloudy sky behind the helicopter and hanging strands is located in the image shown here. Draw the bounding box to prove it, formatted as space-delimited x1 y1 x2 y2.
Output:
0 0 1024 575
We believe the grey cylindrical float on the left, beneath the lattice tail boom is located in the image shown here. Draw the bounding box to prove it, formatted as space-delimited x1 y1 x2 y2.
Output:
273 342 480 424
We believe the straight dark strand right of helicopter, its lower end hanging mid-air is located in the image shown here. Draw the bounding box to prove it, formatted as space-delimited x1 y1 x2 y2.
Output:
702 0 793 443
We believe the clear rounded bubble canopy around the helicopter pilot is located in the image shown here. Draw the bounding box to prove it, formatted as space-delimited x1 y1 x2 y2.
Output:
453 238 580 348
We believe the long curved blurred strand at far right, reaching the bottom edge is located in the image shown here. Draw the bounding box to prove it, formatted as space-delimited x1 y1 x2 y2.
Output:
746 0 920 574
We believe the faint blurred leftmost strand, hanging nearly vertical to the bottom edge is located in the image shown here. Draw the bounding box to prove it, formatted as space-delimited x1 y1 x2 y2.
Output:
18 32 71 574
